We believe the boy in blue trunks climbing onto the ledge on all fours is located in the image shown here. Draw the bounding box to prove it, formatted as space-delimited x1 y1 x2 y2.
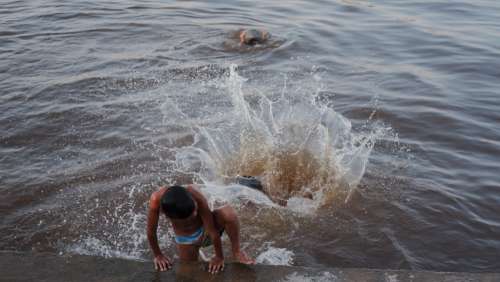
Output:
147 185 255 274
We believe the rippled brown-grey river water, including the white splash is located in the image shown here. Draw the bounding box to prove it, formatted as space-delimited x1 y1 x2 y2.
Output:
0 0 500 272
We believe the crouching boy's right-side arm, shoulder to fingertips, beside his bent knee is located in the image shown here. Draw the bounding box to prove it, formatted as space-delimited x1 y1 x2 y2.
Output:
189 186 224 273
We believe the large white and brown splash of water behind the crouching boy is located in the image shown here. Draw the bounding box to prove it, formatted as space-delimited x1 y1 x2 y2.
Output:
172 65 382 207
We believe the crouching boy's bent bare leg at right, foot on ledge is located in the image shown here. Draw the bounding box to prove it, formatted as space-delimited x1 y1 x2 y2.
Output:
213 205 254 263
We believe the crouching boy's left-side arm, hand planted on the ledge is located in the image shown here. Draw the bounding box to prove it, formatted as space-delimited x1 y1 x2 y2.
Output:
147 192 172 271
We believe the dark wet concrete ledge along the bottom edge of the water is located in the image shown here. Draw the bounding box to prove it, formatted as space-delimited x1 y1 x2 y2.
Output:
0 252 500 282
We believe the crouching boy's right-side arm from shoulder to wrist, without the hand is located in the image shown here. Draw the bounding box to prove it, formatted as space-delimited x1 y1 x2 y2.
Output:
189 185 224 259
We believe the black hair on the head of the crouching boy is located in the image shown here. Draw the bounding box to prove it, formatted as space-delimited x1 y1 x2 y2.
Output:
160 186 195 219
